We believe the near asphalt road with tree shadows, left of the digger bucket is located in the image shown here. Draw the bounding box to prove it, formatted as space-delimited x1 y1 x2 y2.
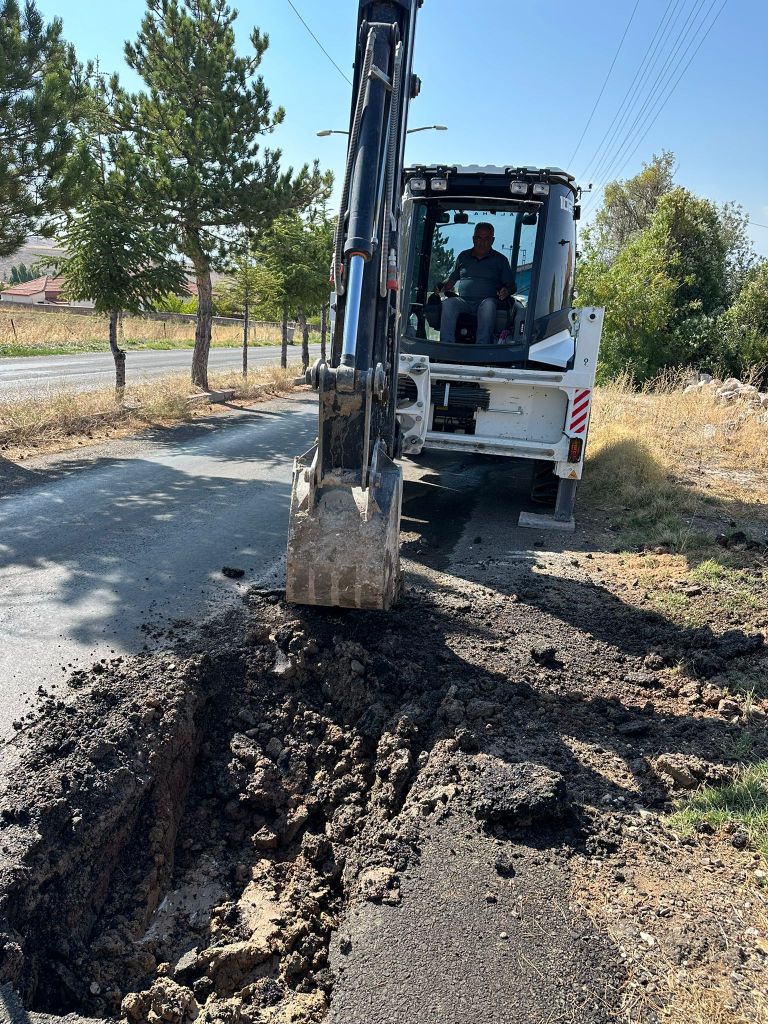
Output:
0 396 316 741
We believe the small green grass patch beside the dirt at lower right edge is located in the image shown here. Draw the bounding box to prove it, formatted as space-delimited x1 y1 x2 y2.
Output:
670 761 768 862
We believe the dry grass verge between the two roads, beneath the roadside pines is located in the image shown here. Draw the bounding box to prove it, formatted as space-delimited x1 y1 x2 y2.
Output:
0 366 300 459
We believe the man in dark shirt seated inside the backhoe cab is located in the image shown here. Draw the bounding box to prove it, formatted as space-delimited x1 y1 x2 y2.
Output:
438 223 515 345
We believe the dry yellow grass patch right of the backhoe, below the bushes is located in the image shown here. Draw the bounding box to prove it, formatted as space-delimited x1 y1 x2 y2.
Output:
584 374 768 551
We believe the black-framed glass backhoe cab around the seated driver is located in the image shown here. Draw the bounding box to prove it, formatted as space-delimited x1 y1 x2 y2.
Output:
400 167 579 369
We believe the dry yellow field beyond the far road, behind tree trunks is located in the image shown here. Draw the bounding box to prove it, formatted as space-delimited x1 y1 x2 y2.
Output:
0 305 314 357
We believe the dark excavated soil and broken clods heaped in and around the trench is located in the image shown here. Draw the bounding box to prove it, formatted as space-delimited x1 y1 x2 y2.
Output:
0 565 768 1024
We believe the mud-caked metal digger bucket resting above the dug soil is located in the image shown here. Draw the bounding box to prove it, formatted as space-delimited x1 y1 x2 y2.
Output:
286 444 402 610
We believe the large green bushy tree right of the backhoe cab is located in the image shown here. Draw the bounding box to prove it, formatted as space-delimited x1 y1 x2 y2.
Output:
578 154 755 380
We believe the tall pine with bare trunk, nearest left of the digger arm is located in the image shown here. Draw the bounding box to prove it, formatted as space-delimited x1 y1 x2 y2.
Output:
122 0 331 387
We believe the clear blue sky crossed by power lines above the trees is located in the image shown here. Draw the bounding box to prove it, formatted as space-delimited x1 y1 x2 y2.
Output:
37 0 768 256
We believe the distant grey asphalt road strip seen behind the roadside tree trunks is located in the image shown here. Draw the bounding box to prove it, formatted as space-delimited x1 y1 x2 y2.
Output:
0 345 319 400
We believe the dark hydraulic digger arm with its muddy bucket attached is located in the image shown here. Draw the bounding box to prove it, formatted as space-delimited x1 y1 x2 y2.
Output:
286 0 423 608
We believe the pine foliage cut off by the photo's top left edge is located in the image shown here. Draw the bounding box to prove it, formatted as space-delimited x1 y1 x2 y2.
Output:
0 0 82 256
